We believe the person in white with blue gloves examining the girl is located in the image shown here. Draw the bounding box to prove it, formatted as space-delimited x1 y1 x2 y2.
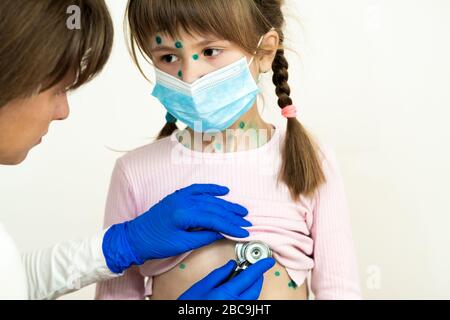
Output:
0 0 274 299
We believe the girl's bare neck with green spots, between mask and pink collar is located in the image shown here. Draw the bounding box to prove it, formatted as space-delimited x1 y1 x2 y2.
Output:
177 104 274 153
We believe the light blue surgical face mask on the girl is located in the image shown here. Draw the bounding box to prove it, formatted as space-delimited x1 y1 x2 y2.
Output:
152 33 264 132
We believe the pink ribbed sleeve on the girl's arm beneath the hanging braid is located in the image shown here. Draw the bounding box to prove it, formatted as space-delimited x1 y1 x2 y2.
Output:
311 147 362 300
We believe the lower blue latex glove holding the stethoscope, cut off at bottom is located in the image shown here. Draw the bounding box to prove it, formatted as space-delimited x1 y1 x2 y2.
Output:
178 258 275 300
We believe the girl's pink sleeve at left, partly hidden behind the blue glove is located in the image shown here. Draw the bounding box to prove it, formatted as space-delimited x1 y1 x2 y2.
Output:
95 159 145 300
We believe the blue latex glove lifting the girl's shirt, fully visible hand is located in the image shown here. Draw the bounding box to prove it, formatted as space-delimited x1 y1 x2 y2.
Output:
102 184 252 273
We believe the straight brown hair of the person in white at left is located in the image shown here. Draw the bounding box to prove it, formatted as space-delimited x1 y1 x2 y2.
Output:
0 0 114 107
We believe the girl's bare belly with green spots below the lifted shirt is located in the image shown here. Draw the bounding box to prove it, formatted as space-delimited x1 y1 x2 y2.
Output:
150 239 308 300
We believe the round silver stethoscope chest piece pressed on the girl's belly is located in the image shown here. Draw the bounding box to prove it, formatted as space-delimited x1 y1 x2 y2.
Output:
228 241 272 280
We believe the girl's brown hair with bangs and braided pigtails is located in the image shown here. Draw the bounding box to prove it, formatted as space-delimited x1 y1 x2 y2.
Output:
126 0 325 199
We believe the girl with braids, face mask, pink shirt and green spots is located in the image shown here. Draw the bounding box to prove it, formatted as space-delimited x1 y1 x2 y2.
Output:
96 0 361 299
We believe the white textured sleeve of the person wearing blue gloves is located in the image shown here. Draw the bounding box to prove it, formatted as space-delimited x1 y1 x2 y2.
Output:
0 223 120 300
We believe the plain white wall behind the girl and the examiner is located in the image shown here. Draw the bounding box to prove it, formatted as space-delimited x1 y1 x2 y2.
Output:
0 0 450 299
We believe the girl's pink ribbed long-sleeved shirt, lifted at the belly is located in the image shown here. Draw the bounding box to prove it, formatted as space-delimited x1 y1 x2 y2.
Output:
96 124 361 299
